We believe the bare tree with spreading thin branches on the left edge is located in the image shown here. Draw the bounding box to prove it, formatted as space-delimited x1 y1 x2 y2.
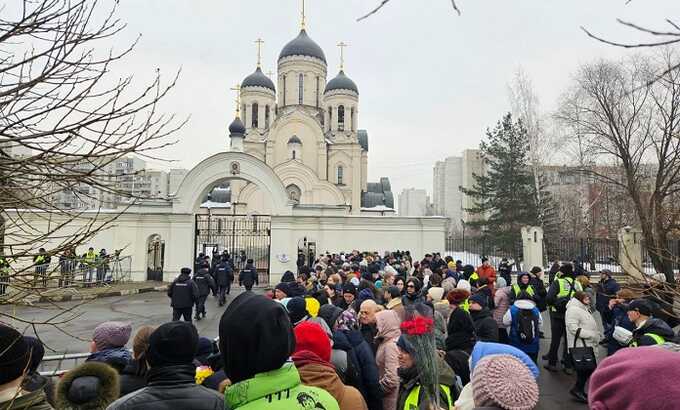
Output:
0 0 183 319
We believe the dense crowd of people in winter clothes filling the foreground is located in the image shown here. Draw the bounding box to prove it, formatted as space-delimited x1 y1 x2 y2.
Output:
0 251 680 410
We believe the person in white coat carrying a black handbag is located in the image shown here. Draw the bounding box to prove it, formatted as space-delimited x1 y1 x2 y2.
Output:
564 291 601 403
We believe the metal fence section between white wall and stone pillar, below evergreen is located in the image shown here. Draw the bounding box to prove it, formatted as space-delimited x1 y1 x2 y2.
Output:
445 237 524 270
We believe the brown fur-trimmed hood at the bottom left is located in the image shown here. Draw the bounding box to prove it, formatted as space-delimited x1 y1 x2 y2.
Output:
56 362 120 410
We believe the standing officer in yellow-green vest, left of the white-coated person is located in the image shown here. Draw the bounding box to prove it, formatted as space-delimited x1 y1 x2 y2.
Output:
543 263 583 374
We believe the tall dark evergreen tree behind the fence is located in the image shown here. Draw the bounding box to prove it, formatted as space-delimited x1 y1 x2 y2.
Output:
461 113 554 252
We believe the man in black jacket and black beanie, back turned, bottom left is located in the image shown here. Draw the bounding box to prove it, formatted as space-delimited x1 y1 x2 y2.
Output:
109 322 224 410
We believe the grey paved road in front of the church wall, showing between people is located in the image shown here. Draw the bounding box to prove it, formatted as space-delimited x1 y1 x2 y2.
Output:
0 293 587 410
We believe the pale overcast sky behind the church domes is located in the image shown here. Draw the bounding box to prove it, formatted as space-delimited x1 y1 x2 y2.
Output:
117 0 680 199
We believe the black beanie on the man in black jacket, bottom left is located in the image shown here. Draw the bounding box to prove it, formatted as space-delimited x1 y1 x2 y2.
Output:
147 322 198 367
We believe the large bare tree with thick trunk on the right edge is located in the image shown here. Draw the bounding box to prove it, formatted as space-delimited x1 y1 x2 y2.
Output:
558 52 680 283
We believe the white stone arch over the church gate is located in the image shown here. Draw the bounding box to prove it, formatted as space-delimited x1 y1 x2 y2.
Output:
172 152 292 215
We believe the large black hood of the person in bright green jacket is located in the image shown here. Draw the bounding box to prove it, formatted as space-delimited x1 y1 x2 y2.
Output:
219 292 295 383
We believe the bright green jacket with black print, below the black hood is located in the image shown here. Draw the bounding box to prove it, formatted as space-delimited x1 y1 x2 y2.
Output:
224 363 339 410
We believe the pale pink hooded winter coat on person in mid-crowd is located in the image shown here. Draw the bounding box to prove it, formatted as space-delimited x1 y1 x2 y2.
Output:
375 310 401 410
